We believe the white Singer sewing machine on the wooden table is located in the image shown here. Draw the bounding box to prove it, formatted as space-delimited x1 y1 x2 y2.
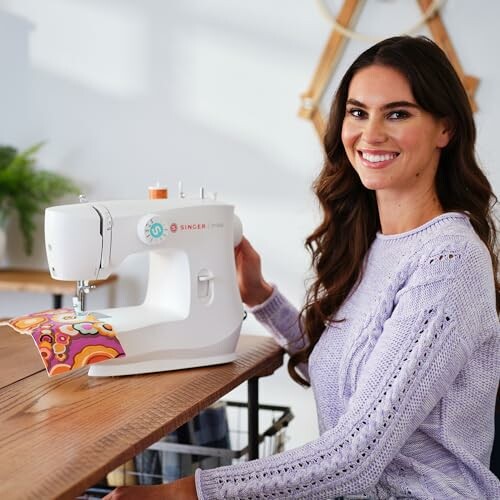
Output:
45 191 244 376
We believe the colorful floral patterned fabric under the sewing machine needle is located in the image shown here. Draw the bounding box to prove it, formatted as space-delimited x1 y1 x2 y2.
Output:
4 309 125 376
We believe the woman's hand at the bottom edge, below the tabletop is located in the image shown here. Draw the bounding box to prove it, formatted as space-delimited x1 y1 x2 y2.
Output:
103 476 198 500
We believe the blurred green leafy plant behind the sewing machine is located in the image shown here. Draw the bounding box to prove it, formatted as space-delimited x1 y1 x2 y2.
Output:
0 143 79 258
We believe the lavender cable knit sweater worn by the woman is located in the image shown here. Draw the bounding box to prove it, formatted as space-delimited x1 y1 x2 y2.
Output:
196 213 500 500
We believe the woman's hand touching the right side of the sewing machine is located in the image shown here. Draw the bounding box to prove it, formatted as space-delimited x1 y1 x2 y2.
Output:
234 237 273 307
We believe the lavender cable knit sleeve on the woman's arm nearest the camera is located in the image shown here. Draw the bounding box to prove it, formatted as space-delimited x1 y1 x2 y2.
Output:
196 243 498 500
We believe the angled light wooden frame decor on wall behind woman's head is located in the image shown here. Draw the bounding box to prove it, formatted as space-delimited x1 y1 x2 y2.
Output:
299 0 479 139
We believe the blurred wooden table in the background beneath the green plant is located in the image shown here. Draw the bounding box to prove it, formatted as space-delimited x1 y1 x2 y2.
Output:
0 269 117 309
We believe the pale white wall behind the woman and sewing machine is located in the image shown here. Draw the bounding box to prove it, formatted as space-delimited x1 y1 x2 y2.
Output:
0 0 500 445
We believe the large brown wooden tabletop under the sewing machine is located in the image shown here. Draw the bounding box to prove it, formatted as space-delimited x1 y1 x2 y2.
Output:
0 327 283 500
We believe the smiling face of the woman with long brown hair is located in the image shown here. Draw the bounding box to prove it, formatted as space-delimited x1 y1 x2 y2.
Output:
342 65 450 196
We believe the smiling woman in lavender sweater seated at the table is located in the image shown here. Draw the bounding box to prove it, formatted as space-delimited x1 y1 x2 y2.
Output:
104 37 500 499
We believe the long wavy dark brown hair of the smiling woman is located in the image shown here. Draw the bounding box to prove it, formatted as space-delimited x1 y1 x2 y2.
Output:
288 36 500 385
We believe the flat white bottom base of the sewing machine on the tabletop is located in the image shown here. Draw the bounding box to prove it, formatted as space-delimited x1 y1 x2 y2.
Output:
88 352 236 377
